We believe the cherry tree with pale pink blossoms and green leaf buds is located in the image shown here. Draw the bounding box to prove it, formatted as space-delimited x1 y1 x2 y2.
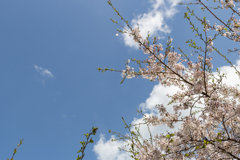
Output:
98 0 240 160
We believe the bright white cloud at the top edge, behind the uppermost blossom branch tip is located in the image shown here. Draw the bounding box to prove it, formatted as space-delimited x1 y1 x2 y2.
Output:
123 0 183 49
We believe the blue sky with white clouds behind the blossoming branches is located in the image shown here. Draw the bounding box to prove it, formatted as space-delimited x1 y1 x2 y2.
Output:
0 0 240 160
